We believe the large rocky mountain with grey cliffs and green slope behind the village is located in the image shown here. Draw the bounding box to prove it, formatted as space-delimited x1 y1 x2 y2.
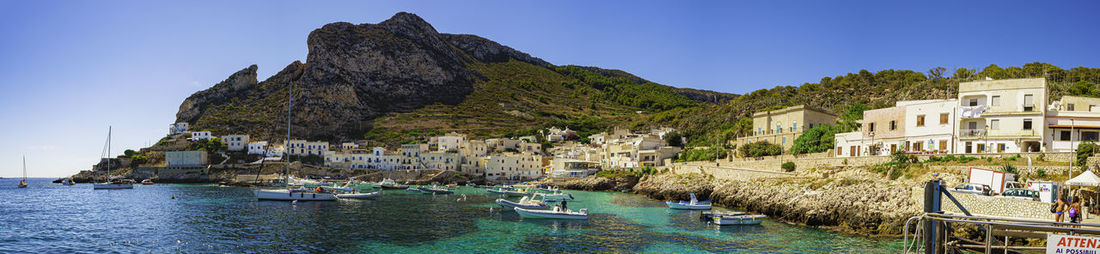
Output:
176 12 737 144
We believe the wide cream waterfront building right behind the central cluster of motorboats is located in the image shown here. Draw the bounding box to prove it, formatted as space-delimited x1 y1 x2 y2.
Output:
485 153 542 181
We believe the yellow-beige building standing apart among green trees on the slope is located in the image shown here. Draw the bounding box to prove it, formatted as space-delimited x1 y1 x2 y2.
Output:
734 106 837 150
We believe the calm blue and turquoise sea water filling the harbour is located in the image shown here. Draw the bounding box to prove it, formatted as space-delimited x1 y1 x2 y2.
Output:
0 178 901 253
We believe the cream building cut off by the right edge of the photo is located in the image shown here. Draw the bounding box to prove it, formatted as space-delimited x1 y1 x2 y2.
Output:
1043 96 1100 153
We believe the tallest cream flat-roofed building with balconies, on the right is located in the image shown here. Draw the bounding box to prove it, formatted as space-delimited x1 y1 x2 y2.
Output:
956 78 1047 154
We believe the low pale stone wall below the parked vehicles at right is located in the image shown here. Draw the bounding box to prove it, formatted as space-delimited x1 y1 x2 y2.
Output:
941 191 1054 221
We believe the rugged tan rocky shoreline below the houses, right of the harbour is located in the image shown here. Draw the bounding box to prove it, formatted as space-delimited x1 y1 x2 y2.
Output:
556 170 922 236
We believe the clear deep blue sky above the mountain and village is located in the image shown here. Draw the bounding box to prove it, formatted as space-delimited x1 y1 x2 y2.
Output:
0 0 1100 177
